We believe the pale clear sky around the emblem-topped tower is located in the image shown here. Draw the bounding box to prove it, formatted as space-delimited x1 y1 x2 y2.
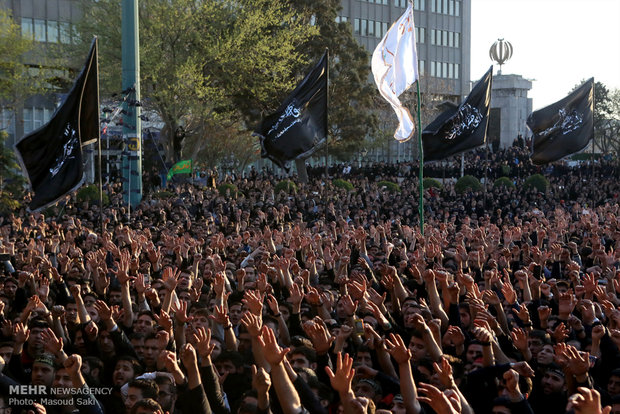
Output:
471 0 620 110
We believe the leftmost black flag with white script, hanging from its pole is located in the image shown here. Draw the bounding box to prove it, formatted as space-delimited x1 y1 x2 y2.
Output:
15 38 99 211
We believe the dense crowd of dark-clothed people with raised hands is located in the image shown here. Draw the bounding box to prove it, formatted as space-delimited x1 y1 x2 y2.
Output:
0 148 620 414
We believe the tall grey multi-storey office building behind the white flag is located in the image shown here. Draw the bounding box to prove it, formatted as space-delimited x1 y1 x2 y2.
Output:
339 0 470 162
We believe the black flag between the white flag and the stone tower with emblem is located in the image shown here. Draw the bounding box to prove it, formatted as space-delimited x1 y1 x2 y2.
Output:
422 66 493 161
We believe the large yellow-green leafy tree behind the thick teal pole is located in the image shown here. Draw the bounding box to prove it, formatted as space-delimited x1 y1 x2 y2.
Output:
72 0 317 165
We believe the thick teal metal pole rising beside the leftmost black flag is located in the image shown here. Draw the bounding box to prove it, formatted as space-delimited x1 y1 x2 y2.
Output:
121 0 142 208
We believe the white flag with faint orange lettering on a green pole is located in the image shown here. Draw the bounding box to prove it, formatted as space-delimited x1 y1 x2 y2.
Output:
372 2 419 141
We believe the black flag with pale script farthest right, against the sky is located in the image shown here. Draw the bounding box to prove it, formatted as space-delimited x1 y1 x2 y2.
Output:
527 78 594 165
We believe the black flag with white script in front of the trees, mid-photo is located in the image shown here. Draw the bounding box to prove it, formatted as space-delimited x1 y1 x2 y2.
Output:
254 52 328 170
